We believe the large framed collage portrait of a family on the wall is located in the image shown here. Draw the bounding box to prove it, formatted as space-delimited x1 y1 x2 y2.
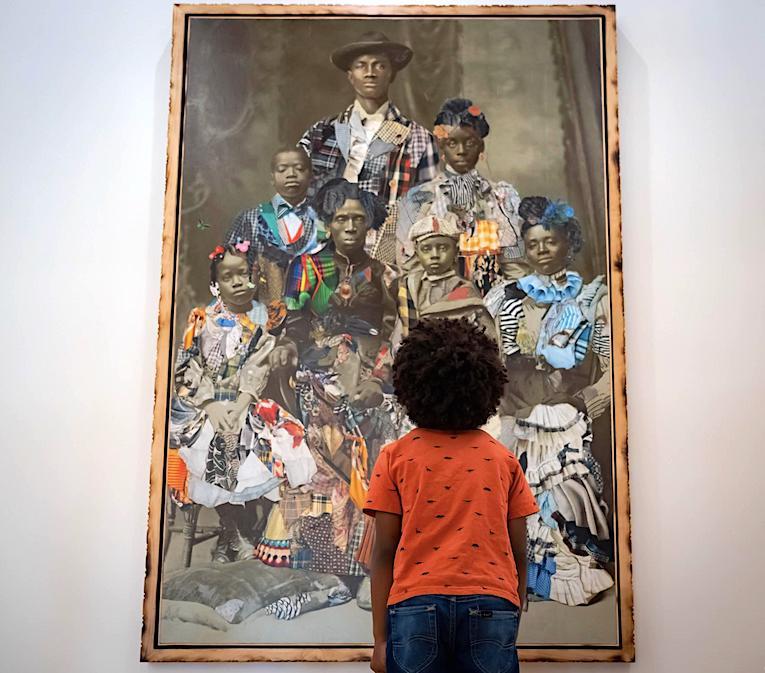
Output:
141 5 634 661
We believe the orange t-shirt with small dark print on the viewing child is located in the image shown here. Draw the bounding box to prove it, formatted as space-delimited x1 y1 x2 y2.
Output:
364 428 539 605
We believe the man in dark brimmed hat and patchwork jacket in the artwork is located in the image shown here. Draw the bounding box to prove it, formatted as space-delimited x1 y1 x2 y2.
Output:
298 31 438 258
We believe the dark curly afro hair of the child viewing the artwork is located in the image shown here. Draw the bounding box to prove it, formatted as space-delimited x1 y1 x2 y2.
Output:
393 318 507 430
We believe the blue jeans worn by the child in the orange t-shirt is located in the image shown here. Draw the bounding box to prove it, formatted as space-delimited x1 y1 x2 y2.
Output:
386 595 520 673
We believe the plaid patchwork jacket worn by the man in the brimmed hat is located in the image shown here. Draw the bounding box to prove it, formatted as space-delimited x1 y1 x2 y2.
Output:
298 103 438 206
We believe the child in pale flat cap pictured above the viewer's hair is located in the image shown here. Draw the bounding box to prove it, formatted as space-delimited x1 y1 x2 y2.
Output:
399 213 496 337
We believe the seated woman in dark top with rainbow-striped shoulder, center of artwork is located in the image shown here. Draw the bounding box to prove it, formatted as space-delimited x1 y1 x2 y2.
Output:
264 178 397 576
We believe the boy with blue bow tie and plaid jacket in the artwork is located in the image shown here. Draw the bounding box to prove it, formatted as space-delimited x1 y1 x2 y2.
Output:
226 147 327 304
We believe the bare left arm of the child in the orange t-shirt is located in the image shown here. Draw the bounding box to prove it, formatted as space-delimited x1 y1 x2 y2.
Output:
370 512 402 671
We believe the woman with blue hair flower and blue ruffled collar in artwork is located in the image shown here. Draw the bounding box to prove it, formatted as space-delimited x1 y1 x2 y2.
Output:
485 196 613 605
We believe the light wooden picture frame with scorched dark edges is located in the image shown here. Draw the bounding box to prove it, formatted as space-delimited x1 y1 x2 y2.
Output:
141 5 635 662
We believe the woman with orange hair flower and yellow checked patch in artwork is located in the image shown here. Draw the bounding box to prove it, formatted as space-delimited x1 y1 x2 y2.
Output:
397 98 523 295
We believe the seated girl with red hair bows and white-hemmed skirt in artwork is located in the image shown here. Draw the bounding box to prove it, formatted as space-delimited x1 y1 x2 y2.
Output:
171 241 310 562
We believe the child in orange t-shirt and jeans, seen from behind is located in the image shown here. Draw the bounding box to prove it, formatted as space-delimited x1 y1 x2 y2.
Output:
364 318 538 673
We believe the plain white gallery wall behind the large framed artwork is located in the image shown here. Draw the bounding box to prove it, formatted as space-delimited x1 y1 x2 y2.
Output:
0 0 765 673
